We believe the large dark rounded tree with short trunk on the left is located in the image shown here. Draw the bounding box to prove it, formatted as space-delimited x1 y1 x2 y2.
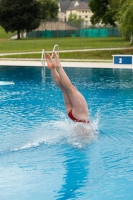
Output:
0 0 41 39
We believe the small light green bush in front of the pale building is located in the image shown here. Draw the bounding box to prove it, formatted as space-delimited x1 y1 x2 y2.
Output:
68 13 84 28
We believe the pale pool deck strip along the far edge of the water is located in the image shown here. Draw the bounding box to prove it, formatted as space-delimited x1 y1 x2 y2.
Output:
0 60 133 69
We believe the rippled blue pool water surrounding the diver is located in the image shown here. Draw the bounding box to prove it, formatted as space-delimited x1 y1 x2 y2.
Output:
0 67 133 200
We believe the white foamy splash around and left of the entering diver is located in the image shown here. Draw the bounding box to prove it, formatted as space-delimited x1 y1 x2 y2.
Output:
12 114 98 151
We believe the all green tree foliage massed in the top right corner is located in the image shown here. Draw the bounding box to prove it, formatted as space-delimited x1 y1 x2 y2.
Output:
89 0 133 43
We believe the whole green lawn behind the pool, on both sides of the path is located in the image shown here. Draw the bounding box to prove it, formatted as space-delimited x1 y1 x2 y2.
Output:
0 27 133 59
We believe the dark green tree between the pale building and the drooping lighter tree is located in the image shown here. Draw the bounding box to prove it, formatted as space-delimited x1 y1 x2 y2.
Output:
89 0 116 26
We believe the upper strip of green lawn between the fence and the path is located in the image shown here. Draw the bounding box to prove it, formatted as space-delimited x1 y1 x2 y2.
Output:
0 37 129 53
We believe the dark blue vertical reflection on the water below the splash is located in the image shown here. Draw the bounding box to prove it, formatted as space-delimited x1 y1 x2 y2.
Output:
56 145 89 200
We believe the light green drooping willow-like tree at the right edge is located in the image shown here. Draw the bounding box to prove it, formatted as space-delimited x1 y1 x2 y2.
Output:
117 0 133 44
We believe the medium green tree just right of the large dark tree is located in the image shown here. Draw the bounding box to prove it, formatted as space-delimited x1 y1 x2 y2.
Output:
39 0 59 20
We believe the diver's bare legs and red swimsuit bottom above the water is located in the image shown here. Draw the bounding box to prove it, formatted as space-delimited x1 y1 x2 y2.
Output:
46 52 90 123
